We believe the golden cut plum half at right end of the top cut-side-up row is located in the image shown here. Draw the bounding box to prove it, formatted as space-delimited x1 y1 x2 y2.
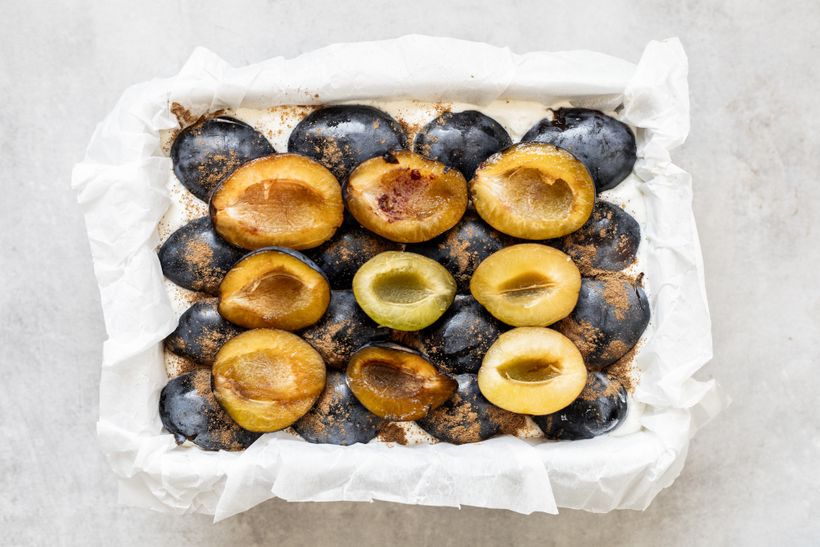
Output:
470 143 595 240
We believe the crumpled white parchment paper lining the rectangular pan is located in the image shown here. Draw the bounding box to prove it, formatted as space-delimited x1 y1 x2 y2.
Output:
72 36 724 520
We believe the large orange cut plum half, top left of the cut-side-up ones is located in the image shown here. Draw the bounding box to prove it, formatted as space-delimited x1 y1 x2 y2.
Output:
210 154 344 249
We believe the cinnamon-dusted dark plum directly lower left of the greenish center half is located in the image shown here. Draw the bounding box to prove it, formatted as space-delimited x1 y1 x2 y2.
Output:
301 290 389 369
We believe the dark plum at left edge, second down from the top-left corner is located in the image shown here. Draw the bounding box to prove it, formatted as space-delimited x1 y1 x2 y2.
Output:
159 217 246 295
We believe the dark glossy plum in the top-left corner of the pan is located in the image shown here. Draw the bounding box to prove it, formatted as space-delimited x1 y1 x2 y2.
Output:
171 116 276 201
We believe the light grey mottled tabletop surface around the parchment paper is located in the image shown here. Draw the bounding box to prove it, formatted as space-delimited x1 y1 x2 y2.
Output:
0 0 820 546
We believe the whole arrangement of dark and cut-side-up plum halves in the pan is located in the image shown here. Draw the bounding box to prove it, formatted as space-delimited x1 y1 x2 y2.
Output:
159 105 649 450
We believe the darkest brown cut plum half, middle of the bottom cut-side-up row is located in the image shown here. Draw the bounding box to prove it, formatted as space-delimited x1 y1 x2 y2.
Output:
347 343 457 421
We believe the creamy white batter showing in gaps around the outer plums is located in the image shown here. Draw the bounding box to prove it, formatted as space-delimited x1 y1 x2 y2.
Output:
158 100 653 444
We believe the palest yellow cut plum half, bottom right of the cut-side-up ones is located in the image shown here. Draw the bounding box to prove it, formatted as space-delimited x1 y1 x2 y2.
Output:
478 327 587 415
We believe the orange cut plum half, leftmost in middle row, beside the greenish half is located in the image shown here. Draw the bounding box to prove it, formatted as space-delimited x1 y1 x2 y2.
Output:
219 247 330 330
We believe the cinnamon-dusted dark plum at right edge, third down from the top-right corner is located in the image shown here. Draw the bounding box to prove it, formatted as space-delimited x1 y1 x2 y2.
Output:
556 274 649 370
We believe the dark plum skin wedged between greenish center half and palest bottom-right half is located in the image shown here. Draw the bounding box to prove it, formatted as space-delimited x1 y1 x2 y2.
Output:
419 295 504 374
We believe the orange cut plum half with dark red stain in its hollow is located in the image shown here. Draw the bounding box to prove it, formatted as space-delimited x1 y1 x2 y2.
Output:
345 150 467 243
